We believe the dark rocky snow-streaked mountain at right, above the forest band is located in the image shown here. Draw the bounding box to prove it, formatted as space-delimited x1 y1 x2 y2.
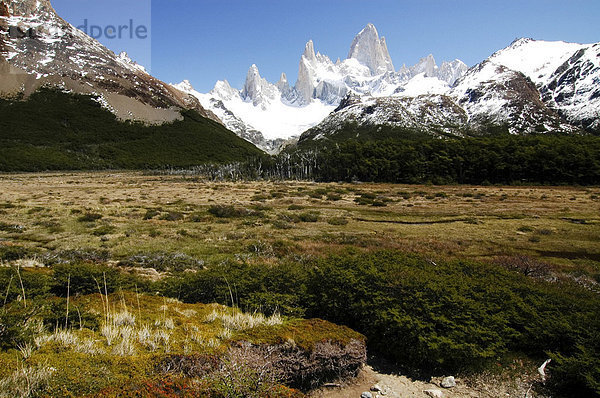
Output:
300 39 600 142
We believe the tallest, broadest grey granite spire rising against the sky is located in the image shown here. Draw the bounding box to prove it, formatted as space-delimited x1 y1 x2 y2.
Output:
348 24 395 75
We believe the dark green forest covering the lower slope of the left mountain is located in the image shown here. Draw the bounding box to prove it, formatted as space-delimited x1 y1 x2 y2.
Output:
0 89 262 171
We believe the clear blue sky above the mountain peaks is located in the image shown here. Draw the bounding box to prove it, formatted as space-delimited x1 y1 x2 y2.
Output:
53 0 600 92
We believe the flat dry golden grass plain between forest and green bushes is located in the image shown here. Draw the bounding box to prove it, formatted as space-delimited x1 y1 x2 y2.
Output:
0 172 600 276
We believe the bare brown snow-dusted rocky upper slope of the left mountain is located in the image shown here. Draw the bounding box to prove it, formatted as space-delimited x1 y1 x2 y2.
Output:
0 0 216 123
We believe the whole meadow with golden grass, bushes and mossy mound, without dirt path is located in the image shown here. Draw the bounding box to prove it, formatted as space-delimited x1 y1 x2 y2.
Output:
0 172 600 397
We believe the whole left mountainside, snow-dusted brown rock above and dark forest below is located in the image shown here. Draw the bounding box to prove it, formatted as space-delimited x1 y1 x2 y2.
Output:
0 0 263 171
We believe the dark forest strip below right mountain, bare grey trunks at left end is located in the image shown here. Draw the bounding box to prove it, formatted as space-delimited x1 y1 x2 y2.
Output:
164 134 600 185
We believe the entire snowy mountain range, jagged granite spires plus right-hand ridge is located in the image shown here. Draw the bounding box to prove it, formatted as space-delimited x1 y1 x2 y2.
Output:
175 24 600 153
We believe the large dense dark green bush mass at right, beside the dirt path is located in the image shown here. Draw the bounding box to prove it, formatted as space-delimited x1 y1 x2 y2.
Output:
161 252 600 396
